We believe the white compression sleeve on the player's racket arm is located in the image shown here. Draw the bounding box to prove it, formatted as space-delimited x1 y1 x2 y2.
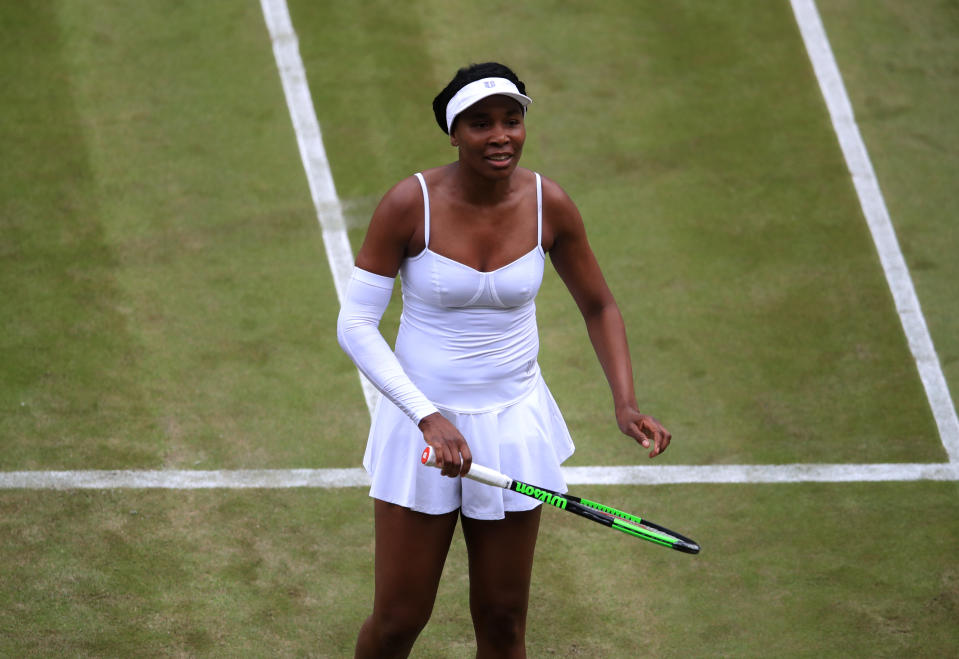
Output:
336 267 438 424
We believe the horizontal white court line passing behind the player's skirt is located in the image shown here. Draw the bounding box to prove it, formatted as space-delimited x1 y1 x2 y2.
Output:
0 462 959 490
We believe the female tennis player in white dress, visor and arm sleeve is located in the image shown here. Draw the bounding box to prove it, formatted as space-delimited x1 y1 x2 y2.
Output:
337 63 671 657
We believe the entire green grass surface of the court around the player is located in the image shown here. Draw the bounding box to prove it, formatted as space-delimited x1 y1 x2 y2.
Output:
0 0 959 657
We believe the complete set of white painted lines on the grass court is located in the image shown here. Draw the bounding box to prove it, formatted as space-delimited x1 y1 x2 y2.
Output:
0 0 959 496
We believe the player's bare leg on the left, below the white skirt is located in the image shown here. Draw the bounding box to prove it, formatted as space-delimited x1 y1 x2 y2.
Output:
356 499 459 657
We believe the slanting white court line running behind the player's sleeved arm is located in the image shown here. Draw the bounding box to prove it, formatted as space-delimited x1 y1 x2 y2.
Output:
260 0 379 414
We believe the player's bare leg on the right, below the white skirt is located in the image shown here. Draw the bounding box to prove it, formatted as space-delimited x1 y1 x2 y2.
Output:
463 506 542 657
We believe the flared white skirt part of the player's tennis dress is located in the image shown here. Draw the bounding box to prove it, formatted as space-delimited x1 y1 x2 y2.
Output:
363 377 575 519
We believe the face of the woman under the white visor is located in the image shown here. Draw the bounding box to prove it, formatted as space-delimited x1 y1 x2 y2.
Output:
450 96 526 178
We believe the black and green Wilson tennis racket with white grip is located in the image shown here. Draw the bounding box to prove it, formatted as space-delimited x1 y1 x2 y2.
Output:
420 446 699 554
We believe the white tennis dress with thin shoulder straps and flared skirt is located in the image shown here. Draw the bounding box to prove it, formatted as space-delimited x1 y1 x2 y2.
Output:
363 173 574 519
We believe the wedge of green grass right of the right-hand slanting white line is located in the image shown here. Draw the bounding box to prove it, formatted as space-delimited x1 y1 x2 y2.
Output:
820 0 959 412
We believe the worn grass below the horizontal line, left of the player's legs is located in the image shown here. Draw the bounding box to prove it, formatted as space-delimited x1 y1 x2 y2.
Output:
0 489 372 657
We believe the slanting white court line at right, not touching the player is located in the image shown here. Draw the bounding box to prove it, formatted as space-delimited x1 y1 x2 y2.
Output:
791 0 959 463
